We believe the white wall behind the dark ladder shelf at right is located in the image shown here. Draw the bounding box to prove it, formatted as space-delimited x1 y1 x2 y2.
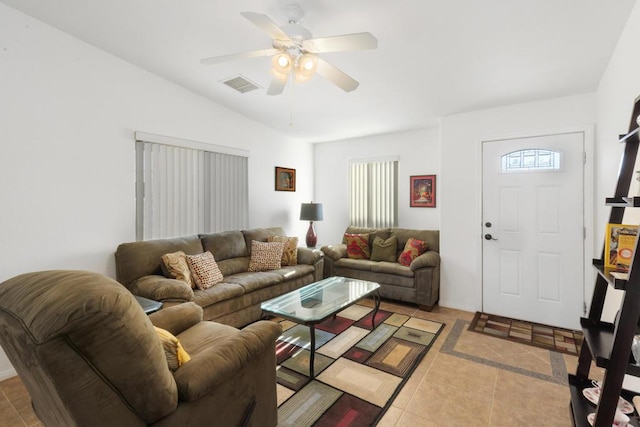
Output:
596 3 640 320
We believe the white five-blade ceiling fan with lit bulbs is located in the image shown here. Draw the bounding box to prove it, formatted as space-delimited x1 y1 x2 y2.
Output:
200 4 378 95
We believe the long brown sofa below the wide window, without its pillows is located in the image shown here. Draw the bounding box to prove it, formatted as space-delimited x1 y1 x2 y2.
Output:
115 227 324 327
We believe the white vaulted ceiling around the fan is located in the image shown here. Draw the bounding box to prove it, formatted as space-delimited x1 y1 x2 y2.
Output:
0 0 635 142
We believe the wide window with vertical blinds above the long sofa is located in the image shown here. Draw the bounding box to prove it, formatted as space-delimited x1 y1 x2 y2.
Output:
136 132 249 240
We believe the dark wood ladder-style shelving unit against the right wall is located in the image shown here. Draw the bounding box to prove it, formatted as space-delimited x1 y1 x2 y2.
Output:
568 97 640 427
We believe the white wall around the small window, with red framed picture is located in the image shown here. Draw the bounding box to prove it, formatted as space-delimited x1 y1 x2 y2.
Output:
314 128 441 244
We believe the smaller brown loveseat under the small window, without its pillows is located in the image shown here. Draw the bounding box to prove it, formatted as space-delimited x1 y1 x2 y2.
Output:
322 226 440 311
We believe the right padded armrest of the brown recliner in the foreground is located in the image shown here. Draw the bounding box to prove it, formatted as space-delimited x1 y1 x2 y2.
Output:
174 320 282 402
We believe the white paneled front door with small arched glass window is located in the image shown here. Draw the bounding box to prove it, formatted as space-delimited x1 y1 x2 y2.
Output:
482 132 584 329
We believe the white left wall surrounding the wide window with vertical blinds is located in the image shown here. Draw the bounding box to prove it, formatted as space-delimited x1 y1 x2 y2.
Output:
0 4 313 379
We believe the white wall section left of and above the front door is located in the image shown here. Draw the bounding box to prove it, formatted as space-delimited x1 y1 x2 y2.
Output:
440 94 595 311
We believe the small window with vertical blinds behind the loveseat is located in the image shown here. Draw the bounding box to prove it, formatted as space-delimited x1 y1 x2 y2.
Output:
349 158 398 228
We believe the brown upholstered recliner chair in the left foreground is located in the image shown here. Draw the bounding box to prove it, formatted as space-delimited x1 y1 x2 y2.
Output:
0 271 281 426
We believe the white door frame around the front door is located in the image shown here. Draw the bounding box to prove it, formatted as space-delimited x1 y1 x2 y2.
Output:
476 125 604 313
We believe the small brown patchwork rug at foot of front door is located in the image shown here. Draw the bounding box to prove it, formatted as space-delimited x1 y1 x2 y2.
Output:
469 312 583 356
